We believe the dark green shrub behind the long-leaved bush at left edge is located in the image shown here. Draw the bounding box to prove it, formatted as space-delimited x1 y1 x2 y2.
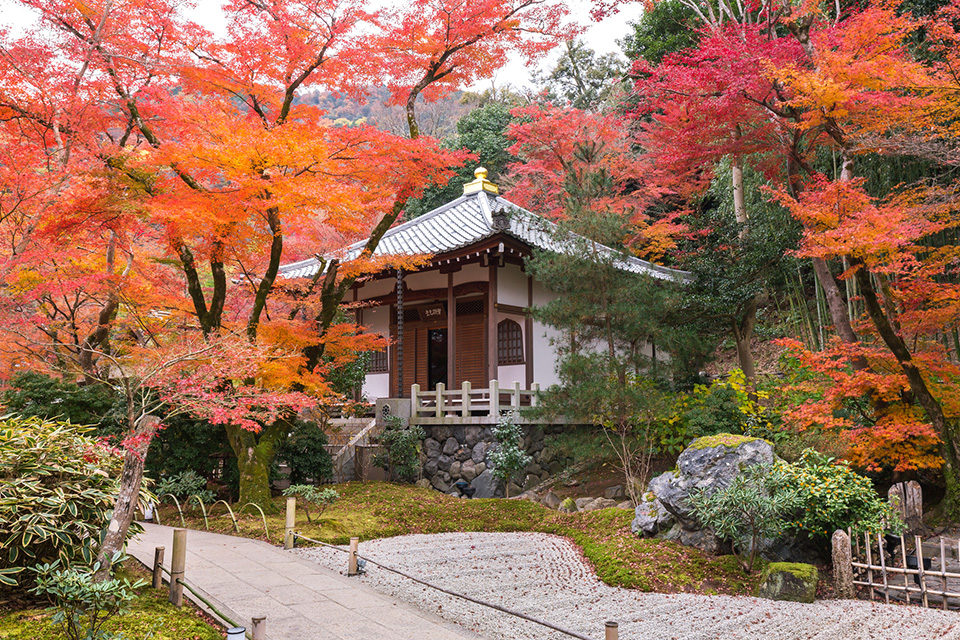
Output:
0 371 127 436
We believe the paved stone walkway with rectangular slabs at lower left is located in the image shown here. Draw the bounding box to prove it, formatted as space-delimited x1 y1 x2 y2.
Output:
127 524 479 640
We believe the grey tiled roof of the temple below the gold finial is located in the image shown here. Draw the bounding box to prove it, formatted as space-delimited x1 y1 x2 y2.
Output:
280 191 689 280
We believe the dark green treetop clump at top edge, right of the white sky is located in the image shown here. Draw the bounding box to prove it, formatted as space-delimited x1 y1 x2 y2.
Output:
623 0 700 64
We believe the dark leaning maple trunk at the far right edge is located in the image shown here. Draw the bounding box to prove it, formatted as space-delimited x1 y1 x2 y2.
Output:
850 259 960 518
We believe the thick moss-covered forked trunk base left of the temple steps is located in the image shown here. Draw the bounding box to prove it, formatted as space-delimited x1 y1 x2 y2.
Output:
226 420 286 512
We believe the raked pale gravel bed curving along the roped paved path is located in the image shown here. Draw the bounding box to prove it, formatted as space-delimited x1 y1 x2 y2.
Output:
297 533 960 640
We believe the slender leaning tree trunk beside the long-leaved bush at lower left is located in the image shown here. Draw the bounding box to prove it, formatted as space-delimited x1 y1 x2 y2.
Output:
95 414 160 581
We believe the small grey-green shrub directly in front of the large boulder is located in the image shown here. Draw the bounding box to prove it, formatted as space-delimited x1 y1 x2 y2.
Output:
690 465 796 571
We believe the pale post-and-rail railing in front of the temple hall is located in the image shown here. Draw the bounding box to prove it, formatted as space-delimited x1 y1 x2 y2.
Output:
410 380 540 421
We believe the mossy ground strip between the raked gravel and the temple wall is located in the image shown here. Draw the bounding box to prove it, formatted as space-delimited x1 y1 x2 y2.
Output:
154 482 759 595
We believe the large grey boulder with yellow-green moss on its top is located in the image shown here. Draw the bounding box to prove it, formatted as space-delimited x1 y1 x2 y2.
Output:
648 433 774 530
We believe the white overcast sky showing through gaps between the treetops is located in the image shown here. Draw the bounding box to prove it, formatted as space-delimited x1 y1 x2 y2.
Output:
0 0 643 89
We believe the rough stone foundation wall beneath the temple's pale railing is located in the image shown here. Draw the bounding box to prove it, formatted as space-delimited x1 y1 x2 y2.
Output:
423 425 571 498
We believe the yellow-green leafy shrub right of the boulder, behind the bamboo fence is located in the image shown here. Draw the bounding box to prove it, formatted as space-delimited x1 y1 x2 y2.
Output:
770 449 903 544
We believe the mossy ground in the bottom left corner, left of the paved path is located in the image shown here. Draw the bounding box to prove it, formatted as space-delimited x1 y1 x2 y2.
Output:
0 561 223 640
